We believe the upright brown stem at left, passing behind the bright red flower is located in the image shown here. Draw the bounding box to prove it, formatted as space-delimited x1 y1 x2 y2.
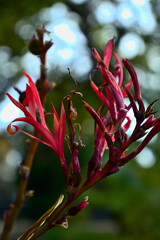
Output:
0 27 48 240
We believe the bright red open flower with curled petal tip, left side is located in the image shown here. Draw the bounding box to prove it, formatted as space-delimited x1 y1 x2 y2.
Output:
6 72 68 176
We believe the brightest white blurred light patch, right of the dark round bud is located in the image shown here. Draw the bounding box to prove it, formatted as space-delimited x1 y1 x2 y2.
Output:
54 23 76 44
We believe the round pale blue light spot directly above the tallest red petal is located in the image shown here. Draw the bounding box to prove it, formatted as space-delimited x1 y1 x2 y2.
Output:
94 2 116 24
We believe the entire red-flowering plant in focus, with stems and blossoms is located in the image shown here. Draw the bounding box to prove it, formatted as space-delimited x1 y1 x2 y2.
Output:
1 34 160 240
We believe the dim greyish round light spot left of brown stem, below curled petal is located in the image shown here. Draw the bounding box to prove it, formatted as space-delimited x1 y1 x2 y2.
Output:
6 149 22 167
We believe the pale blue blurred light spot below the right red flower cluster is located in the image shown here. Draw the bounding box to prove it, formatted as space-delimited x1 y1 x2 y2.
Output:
136 147 156 168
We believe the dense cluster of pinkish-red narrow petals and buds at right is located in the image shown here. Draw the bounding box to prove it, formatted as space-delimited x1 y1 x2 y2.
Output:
84 37 160 179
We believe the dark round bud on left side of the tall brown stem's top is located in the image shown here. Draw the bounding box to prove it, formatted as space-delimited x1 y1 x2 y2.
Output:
28 35 41 56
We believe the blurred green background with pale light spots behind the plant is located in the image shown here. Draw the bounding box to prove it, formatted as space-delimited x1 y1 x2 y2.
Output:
0 0 160 240
